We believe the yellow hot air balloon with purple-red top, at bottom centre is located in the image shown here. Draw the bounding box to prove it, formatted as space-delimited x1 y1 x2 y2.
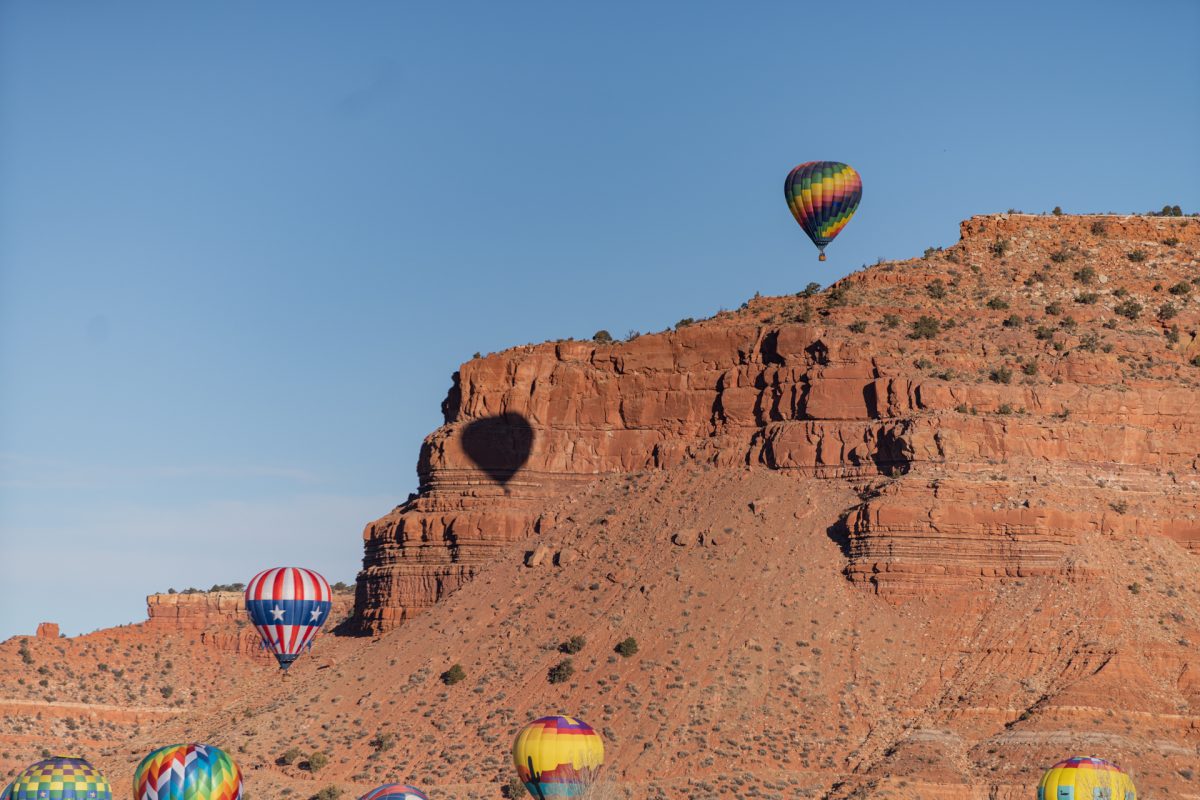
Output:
512 716 604 800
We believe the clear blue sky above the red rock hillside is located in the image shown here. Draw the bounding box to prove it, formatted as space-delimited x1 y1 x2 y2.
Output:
0 0 1200 637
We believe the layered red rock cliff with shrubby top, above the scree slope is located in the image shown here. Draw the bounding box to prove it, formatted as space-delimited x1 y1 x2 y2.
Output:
356 215 1200 632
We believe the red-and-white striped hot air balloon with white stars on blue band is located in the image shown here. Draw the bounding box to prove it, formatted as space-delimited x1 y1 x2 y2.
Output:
246 566 334 669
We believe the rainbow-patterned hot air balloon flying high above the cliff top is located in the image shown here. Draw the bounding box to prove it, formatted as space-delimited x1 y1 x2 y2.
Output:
784 161 863 261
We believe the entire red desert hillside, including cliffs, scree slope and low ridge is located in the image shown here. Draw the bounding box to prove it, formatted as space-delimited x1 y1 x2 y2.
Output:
0 215 1200 800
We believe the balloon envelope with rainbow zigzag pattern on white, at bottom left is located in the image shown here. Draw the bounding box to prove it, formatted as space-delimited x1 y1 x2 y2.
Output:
133 744 241 800
